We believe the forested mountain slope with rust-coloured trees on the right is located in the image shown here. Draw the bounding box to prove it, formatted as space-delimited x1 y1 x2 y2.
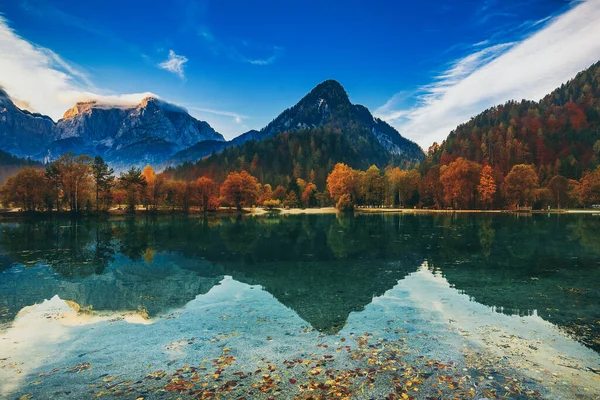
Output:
422 62 600 182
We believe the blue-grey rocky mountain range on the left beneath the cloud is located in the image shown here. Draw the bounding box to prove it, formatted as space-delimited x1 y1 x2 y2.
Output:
0 90 224 166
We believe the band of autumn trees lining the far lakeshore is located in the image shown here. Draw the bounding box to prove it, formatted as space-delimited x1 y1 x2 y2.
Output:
0 149 600 214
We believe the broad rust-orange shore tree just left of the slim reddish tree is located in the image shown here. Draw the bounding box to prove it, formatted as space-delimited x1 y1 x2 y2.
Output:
440 157 481 208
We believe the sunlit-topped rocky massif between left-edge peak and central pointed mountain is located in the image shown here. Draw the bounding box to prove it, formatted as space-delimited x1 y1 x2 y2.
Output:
49 97 224 164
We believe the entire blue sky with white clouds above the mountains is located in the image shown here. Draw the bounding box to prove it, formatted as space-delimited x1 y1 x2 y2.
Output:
0 0 600 150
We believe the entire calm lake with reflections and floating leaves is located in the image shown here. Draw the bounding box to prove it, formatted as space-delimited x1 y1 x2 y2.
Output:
0 214 600 399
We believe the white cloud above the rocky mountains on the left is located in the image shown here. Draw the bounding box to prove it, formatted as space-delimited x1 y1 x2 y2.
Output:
0 16 158 120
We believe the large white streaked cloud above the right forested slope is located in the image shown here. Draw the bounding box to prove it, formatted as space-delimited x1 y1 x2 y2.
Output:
375 0 600 149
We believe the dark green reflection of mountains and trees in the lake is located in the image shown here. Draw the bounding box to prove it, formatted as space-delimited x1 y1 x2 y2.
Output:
0 215 600 351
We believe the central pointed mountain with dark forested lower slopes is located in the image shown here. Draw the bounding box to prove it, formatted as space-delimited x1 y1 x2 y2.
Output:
168 80 424 188
